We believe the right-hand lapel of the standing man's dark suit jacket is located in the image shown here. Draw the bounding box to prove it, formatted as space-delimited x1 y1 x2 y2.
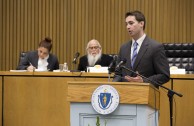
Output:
133 36 149 70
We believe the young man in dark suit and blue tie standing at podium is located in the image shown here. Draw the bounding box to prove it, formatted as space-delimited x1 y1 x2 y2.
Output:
113 11 170 87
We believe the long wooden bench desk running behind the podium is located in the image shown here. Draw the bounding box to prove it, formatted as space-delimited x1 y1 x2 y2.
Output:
0 71 194 126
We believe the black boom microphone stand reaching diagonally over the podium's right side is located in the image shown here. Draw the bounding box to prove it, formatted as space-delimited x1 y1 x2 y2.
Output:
120 65 183 126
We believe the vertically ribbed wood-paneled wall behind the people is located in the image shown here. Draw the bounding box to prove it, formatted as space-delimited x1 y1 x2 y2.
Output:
0 0 194 70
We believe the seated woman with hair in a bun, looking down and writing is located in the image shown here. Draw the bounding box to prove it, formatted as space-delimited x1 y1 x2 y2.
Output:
17 37 59 71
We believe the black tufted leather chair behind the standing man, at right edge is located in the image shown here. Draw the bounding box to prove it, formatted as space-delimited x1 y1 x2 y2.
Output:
163 43 194 74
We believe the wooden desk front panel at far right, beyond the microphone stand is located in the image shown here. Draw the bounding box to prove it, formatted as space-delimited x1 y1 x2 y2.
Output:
173 79 194 126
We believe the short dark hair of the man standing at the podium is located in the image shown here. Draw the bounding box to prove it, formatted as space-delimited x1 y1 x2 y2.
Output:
125 11 146 30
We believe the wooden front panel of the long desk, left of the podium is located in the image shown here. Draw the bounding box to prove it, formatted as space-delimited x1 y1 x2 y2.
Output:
3 75 110 126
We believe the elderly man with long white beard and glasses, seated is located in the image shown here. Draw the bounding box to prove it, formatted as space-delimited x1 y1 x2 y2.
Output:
78 39 113 71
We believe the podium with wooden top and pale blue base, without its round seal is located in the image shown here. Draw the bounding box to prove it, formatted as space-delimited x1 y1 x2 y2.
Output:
67 81 160 126
